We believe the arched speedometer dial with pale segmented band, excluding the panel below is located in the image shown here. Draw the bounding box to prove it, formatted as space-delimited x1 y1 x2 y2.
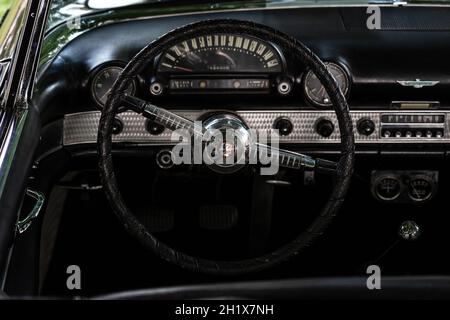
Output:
158 34 282 74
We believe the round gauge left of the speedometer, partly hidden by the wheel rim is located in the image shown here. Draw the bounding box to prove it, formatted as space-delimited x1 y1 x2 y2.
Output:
91 66 136 108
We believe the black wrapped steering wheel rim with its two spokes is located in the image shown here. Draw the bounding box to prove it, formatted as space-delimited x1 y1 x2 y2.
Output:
97 20 355 275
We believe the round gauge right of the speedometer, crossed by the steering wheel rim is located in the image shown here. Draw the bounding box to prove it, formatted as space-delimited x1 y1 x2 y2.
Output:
304 62 350 107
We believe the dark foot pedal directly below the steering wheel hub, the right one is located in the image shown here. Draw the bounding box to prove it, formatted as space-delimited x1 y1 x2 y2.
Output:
198 205 239 230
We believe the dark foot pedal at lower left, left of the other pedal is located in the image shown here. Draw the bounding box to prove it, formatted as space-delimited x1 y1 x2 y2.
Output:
136 208 175 232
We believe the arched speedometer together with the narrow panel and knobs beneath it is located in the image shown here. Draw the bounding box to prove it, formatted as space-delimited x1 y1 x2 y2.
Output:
150 34 284 96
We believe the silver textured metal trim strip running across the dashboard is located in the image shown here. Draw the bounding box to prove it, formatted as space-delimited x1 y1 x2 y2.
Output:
63 110 450 146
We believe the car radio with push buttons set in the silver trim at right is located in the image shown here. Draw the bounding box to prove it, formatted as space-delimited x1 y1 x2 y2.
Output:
380 113 445 139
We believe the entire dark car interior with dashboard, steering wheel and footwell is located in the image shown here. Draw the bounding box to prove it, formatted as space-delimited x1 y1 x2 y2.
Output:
5 2 450 298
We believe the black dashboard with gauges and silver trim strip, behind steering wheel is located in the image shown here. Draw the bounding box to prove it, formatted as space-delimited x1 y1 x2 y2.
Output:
36 7 450 154
